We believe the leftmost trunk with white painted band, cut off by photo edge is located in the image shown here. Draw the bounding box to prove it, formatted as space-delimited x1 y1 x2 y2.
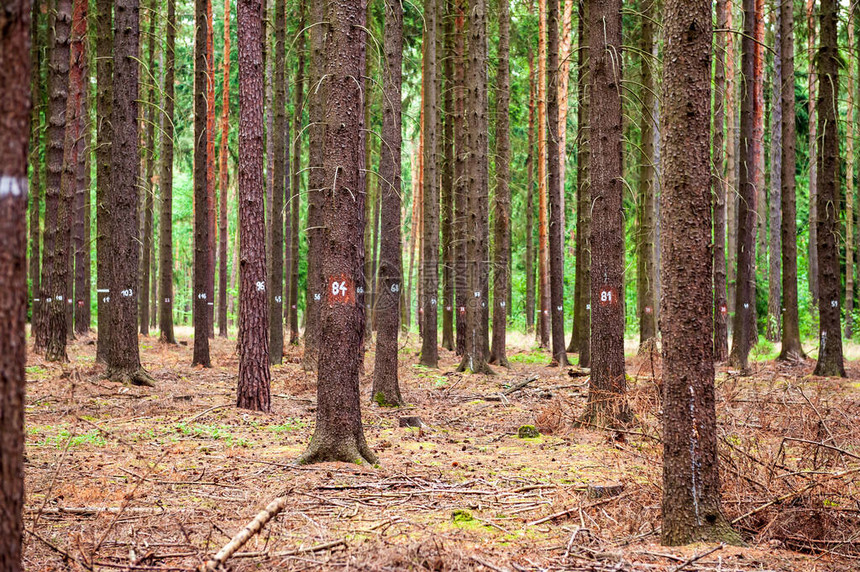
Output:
0 0 31 572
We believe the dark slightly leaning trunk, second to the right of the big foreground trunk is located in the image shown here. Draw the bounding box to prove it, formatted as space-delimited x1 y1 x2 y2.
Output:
729 0 758 370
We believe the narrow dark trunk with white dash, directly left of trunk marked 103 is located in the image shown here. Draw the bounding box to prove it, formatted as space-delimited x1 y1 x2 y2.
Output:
96 0 114 363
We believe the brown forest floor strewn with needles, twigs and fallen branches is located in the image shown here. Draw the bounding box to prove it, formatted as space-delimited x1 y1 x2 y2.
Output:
18 329 860 572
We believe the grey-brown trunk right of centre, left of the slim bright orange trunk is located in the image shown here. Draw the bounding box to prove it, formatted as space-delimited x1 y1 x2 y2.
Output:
489 0 510 367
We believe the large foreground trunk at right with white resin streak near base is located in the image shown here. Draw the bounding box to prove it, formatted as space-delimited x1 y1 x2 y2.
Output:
660 0 740 545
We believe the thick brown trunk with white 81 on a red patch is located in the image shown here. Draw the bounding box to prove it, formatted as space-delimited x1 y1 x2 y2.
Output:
585 0 624 425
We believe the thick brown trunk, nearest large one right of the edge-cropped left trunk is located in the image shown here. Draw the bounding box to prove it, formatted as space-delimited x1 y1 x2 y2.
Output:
45 0 74 361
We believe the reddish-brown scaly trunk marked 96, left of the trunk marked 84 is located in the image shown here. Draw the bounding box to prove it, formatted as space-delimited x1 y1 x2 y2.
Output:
236 0 272 411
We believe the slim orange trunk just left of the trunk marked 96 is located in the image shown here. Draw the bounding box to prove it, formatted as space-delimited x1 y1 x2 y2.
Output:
220 0 230 338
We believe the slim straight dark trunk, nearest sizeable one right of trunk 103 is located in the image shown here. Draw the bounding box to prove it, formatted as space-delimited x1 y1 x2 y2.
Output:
158 0 176 344
